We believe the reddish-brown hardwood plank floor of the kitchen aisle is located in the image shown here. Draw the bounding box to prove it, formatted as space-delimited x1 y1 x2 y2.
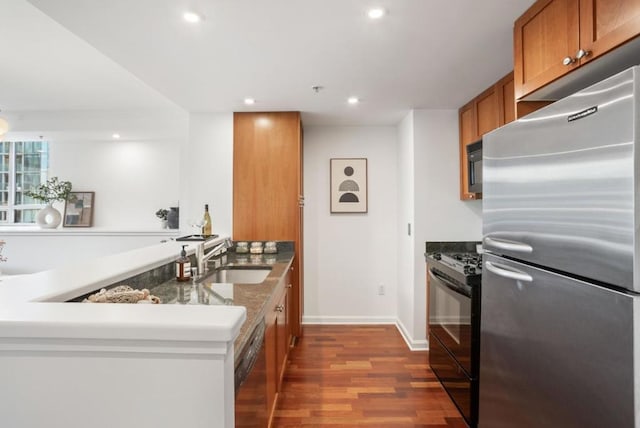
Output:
272 325 466 428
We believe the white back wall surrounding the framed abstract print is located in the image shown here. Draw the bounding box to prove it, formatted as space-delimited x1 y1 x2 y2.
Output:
303 127 397 322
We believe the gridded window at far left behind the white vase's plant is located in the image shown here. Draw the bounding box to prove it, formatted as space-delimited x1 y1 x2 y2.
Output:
0 141 49 224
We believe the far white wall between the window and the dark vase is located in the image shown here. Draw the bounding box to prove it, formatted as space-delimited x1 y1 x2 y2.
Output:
49 141 180 230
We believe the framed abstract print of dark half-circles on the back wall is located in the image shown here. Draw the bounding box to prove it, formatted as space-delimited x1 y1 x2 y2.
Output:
329 158 369 214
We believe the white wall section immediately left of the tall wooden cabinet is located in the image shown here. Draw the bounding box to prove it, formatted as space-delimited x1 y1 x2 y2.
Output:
180 113 233 236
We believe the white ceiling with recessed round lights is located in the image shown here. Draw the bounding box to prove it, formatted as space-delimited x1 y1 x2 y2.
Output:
0 0 533 125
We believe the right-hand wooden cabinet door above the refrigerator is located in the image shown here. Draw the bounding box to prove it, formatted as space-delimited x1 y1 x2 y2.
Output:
580 0 640 64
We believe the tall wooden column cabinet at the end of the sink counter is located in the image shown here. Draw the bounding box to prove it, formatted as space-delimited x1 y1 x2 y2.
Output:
233 112 304 337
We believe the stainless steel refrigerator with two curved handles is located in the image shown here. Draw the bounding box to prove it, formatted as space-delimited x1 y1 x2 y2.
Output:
479 67 640 428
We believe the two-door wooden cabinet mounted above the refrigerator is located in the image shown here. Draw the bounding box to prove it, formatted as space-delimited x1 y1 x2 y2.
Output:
514 0 640 101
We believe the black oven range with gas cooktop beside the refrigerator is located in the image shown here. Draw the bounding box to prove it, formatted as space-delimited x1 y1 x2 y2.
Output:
426 252 482 428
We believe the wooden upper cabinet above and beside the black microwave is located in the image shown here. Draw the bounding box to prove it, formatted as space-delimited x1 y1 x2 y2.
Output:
458 73 515 201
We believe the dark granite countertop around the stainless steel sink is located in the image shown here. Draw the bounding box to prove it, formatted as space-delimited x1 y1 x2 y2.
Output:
149 247 294 363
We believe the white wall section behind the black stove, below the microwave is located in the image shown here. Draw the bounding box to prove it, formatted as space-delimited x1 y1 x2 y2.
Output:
398 110 482 347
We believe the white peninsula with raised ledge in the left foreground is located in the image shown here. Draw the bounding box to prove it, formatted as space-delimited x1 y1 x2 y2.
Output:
0 237 246 428
